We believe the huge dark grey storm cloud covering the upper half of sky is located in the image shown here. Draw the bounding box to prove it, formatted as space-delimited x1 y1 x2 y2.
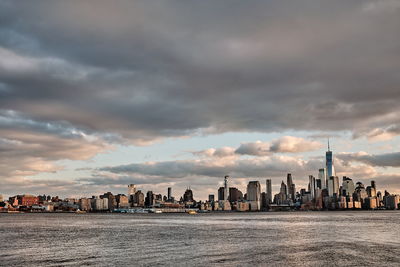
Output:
0 1 400 143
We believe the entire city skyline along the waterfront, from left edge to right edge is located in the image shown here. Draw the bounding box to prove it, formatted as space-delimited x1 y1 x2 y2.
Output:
0 143 400 215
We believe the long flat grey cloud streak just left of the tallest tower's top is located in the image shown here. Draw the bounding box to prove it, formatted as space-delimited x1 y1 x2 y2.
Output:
100 156 322 179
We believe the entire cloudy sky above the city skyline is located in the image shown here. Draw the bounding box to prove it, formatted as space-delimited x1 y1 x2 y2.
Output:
0 0 400 199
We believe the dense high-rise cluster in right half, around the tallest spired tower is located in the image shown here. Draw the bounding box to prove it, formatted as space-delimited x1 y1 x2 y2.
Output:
200 141 400 211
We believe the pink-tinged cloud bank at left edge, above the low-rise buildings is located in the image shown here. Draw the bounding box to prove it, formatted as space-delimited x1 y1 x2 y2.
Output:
0 110 112 190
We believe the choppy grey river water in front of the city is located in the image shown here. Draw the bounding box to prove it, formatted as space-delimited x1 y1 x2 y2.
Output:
0 211 400 266
